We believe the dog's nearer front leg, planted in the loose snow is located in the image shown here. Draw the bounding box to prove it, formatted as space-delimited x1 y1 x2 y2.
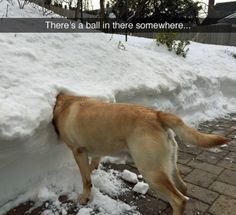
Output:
73 147 92 205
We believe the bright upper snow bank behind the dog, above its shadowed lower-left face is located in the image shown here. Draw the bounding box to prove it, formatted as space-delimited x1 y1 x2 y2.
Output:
0 31 236 140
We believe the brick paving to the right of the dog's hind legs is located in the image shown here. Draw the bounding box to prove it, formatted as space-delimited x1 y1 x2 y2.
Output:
179 114 236 215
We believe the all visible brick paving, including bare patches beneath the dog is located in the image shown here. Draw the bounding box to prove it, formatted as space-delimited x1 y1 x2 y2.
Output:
7 114 236 215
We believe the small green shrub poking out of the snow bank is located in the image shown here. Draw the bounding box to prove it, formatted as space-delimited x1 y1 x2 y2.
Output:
156 32 190 57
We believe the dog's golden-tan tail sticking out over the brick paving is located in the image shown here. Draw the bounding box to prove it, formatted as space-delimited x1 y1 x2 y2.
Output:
157 111 229 148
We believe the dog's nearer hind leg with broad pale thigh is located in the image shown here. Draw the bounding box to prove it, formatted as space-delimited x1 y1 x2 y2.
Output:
128 133 186 215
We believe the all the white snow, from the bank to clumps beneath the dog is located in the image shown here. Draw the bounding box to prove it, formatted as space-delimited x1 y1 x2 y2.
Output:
0 0 236 214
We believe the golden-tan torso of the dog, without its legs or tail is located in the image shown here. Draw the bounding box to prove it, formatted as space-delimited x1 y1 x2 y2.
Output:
53 95 163 155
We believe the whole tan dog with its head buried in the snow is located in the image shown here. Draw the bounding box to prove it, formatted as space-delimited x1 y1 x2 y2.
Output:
53 95 228 215
